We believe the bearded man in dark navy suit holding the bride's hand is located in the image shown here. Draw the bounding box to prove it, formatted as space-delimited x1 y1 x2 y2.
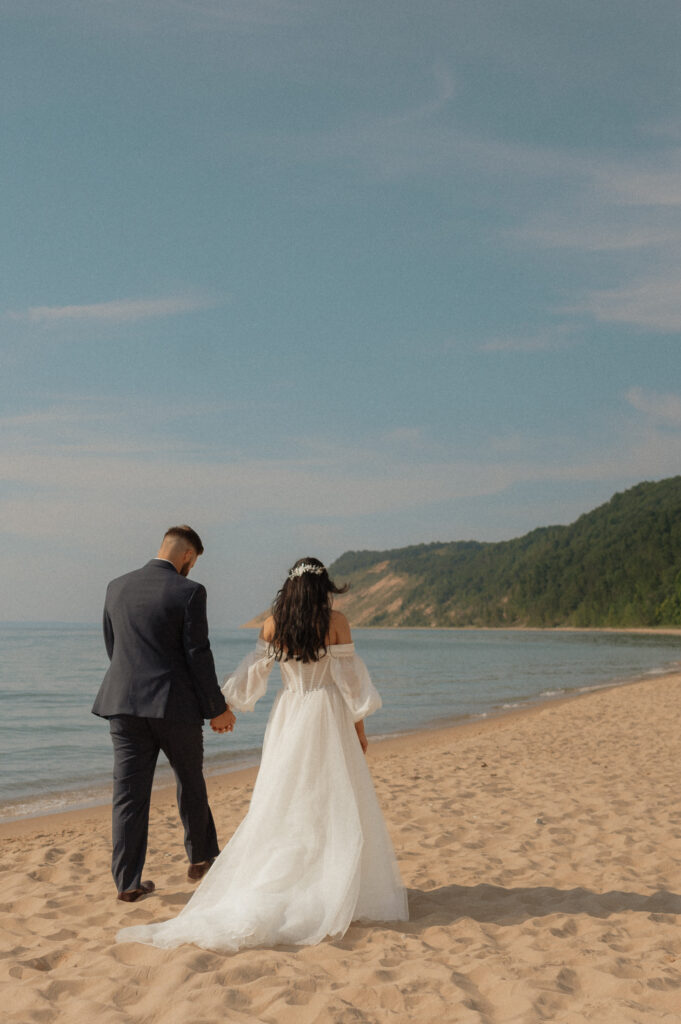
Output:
92 526 235 902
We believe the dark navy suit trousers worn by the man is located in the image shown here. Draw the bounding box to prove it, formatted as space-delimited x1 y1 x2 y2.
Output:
109 715 219 892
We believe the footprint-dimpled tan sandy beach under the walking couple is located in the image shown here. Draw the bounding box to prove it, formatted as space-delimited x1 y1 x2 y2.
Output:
0 676 681 1024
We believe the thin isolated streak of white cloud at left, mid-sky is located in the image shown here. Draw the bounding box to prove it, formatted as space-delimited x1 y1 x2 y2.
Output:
8 296 220 324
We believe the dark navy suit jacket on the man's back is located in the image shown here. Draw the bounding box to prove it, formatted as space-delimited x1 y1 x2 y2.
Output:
92 558 226 722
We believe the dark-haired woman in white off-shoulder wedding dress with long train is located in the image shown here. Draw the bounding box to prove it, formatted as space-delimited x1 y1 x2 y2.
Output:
117 558 409 950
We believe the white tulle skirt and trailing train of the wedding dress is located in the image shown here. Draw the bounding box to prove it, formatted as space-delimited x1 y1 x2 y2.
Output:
117 686 408 950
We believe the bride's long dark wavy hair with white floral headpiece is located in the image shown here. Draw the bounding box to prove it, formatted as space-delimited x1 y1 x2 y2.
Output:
270 558 348 662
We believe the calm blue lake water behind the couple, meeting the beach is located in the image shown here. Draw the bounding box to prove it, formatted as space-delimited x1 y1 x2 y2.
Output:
0 624 681 821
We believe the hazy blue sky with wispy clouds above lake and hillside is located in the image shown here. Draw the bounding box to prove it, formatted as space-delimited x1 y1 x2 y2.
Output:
0 0 681 628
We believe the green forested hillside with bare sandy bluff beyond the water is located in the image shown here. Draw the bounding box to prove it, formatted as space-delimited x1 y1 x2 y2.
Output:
330 476 681 627
